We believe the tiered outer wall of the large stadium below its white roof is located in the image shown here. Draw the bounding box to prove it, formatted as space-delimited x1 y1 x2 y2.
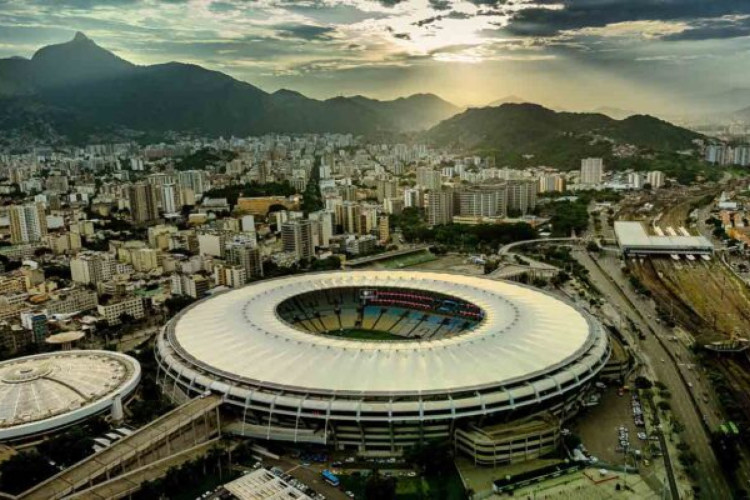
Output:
155 272 611 458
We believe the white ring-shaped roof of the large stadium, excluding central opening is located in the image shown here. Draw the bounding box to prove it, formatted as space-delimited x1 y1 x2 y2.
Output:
169 271 606 394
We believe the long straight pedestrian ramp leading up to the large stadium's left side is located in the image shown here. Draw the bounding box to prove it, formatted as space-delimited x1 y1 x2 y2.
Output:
17 395 222 500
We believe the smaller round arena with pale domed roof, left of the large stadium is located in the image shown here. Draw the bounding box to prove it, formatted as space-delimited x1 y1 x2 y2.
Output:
0 350 141 441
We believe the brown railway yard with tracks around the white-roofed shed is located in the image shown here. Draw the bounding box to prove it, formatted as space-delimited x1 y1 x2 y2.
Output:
614 184 750 496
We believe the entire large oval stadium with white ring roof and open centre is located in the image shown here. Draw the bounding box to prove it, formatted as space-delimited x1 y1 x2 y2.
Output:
156 271 610 463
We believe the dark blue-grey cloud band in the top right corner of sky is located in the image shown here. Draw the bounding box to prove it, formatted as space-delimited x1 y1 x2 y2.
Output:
507 0 750 36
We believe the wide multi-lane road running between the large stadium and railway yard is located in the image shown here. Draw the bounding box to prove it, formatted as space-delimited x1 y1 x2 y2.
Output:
573 249 731 499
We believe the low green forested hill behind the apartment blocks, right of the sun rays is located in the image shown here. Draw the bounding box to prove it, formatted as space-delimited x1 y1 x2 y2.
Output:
425 104 702 167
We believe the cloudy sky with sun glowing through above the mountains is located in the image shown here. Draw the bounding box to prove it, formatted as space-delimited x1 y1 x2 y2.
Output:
0 0 750 114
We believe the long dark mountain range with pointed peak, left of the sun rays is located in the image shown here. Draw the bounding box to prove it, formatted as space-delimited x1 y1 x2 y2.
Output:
0 33 459 137
